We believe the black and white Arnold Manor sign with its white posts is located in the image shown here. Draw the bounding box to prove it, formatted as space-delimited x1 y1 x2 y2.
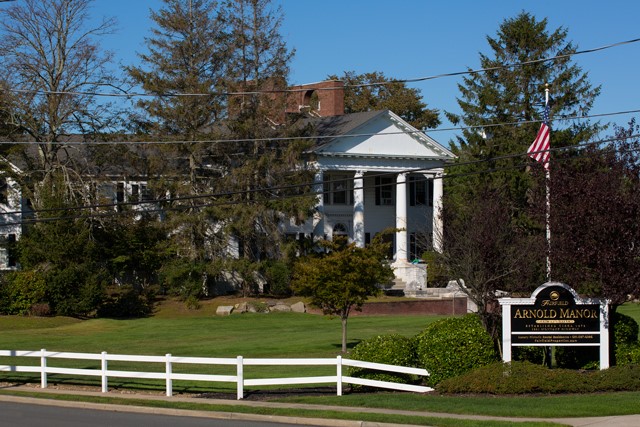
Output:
498 282 609 369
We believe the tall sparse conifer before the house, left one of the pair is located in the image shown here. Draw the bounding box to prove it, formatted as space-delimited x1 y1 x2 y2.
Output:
127 0 228 298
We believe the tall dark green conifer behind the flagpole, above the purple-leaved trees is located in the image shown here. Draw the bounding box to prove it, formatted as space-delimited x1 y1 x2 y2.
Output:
447 12 600 212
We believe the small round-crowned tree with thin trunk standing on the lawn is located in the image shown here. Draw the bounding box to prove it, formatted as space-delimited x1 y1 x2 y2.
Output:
292 238 393 353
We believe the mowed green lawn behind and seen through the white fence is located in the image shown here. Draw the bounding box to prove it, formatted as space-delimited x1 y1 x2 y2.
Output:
0 304 441 392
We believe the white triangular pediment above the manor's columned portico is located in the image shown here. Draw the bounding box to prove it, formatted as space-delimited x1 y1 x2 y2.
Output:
314 110 454 161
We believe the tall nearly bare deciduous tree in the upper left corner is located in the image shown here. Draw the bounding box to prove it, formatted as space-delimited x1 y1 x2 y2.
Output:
0 0 116 206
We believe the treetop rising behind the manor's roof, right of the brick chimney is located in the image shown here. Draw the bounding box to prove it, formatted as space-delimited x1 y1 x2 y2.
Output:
328 71 440 129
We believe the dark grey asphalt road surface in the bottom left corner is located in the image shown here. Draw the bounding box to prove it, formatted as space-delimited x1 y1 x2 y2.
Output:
0 402 320 427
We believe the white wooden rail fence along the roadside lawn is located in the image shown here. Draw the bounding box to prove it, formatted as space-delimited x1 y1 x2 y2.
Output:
0 349 433 400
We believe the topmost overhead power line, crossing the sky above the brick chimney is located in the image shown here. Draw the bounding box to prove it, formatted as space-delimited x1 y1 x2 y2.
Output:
6 38 640 98
